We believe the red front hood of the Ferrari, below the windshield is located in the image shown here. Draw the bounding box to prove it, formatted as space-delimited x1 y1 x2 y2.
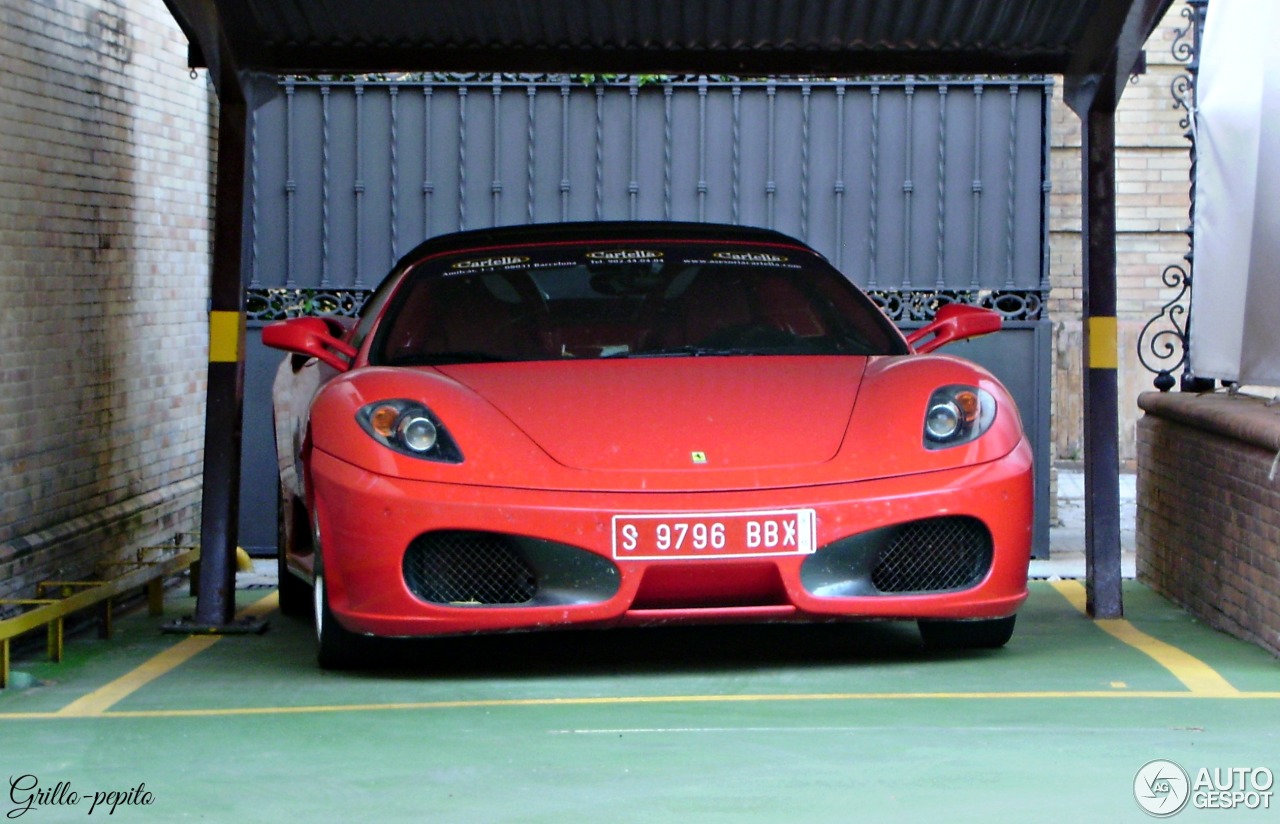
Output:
436 357 867 472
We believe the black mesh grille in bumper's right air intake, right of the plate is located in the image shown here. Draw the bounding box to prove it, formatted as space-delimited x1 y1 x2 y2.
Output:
872 518 991 592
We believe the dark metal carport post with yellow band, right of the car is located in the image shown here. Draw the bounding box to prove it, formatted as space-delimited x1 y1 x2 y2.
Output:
1082 94 1124 618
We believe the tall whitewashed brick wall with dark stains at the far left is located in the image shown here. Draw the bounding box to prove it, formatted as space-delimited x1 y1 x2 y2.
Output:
0 0 210 598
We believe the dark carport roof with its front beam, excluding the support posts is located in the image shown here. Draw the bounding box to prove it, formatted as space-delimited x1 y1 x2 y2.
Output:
165 0 1170 84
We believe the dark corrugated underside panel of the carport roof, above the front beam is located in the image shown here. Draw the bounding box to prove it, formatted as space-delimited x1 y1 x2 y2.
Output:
238 0 1080 52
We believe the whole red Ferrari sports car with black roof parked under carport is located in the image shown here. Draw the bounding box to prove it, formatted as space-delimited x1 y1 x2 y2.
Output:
262 223 1032 667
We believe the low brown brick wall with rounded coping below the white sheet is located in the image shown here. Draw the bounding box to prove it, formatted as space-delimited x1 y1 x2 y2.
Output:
1137 393 1280 655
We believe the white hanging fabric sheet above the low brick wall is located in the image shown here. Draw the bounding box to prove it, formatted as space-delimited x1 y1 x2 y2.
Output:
1190 0 1280 386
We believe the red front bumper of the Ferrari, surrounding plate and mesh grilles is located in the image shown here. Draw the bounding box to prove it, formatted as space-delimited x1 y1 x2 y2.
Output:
311 441 1033 636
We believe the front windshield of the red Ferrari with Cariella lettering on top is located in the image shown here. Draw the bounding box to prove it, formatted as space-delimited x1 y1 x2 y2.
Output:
370 241 906 366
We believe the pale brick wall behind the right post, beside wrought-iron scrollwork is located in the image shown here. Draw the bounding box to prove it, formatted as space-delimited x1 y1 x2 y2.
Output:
1048 0 1190 462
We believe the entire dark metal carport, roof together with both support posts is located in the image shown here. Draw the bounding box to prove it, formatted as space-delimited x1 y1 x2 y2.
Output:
165 0 1172 630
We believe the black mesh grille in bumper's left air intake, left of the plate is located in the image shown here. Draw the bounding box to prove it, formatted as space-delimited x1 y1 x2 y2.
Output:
404 532 538 605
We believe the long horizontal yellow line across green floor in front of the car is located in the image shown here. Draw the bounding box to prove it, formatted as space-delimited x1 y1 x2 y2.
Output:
0 690 1280 722
